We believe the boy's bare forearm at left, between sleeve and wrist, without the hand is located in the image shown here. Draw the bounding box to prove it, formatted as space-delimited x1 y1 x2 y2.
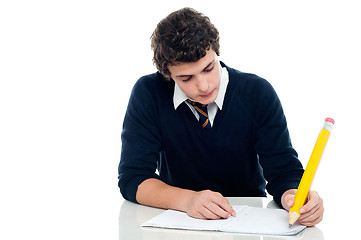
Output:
136 178 194 211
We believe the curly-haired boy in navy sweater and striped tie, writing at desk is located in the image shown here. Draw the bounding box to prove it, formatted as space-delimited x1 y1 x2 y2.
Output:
118 8 324 226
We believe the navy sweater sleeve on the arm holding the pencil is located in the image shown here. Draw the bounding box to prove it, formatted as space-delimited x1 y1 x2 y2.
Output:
250 76 303 207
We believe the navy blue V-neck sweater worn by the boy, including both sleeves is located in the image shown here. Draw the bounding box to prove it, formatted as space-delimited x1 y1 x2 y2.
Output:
118 63 303 205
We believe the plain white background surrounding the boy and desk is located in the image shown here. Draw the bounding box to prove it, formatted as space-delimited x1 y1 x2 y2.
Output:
0 0 361 239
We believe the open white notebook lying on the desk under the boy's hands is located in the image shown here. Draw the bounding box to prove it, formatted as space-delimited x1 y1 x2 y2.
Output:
141 205 306 235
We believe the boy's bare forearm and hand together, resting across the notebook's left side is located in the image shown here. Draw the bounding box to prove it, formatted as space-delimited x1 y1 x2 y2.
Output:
136 178 236 219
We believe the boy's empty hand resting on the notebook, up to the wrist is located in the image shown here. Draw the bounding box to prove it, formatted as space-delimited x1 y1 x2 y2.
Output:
186 190 236 219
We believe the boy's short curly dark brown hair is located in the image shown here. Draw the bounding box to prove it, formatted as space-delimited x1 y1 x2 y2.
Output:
151 8 219 79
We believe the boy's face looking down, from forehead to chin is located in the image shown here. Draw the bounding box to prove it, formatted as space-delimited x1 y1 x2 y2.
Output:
168 49 221 104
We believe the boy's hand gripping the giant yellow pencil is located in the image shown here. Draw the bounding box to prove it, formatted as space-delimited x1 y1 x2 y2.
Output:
281 189 324 227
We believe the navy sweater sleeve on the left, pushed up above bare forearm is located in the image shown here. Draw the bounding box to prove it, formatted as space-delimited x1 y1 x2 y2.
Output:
118 77 160 202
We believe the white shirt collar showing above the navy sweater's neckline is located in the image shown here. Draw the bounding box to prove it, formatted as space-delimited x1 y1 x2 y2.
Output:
173 62 229 110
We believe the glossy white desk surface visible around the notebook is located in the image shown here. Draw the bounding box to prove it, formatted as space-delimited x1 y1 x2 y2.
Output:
119 197 324 240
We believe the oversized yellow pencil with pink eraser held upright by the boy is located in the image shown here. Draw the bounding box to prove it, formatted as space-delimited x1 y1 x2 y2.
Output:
288 118 335 227
